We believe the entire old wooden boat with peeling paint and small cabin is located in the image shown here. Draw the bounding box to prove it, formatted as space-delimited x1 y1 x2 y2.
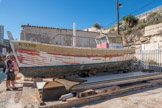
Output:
8 33 135 77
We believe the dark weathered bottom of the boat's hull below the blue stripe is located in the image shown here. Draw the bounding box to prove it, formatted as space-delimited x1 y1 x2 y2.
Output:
20 61 130 77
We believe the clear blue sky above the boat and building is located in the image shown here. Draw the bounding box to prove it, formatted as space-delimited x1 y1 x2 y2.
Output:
0 0 162 39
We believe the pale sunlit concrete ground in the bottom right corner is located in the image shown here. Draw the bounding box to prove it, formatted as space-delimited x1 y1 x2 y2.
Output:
78 86 162 108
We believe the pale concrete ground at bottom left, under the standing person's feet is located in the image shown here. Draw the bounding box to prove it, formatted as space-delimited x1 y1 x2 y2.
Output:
0 80 38 108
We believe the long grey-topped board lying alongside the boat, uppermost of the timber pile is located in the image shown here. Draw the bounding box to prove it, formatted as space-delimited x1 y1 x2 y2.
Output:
71 72 162 92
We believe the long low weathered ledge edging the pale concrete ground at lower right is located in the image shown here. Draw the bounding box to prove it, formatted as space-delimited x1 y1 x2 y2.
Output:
41 79 162 108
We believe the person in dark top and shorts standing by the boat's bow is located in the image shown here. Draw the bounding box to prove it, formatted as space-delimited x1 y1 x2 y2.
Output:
2 55 16 91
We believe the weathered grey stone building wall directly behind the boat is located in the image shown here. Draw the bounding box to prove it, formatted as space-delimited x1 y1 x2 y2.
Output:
20 25 99 47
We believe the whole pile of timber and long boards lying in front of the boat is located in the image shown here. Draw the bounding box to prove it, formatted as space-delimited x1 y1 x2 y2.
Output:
35 72 162 108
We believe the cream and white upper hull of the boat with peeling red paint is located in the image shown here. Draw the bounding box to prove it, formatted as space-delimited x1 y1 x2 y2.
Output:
9 41 134 77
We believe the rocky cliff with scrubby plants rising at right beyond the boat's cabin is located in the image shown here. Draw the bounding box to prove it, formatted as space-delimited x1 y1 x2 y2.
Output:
120 8 162 46
